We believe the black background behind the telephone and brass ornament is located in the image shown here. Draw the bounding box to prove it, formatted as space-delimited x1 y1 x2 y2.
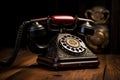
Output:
0 0 120 53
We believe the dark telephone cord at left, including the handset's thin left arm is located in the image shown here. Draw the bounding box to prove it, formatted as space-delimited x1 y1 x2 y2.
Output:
0 17 47 67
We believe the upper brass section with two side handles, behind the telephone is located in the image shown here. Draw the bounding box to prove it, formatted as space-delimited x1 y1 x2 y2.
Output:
85 6 110 24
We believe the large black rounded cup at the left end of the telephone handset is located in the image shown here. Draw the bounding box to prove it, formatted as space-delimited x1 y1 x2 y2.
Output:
27 22 49 54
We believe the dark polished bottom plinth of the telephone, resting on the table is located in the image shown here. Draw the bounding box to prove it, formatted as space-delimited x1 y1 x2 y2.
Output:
37 55 99 69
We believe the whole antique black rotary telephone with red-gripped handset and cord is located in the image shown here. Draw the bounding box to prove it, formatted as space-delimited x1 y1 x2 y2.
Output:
0 15 99 68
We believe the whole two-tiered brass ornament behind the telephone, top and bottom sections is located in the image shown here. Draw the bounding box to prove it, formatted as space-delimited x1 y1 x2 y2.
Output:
85 6 110 53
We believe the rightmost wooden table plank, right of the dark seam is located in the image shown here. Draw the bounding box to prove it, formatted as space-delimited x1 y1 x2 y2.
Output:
105 54 120 80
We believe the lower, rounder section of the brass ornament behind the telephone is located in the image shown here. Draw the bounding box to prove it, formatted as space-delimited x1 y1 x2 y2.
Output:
85 25 109 52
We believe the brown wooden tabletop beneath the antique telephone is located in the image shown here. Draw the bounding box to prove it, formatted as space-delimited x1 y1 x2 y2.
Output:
0 48 120 80
